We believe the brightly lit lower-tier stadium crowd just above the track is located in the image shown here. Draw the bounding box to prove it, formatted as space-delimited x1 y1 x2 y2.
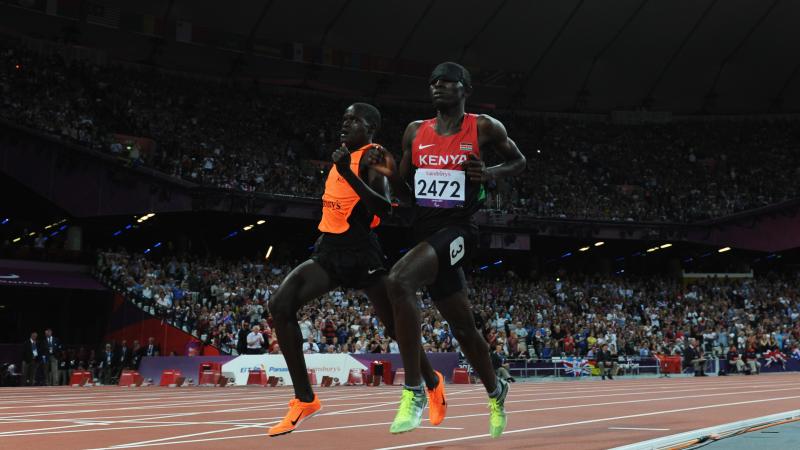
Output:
97 252 800 370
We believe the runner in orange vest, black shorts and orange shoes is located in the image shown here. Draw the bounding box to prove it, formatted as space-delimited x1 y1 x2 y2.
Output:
268 103 447 436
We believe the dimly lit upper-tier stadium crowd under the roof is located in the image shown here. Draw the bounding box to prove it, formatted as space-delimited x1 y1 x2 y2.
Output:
0 41 800 222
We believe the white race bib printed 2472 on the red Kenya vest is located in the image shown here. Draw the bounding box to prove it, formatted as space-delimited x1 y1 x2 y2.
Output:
414 169 466 208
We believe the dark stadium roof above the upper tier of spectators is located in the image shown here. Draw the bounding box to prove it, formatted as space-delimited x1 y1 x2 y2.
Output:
12 0 800 113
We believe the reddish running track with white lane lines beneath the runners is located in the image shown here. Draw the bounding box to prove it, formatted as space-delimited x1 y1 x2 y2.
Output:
0 374 800 450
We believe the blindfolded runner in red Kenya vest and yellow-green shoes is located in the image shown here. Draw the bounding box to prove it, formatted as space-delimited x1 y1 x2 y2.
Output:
368 62 525 437
